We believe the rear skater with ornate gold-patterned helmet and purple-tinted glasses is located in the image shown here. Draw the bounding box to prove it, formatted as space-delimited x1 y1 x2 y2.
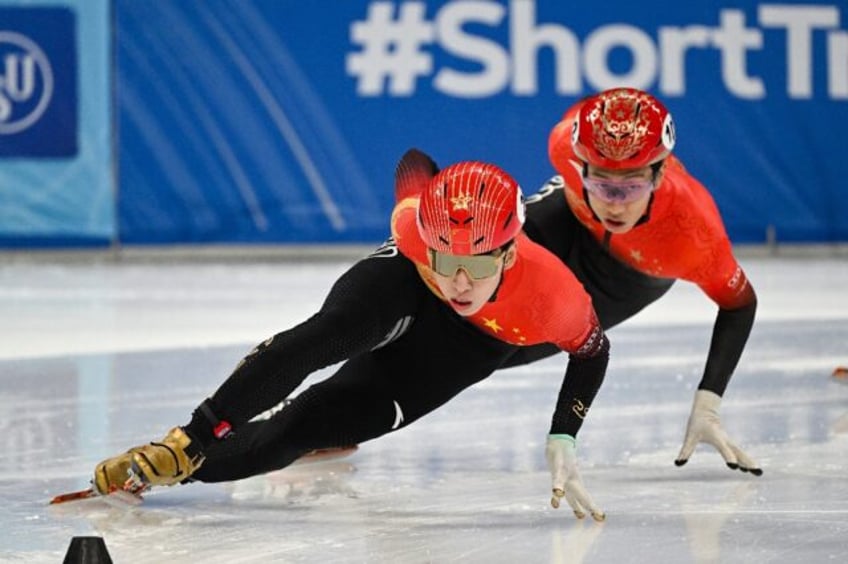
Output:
507 88 762 476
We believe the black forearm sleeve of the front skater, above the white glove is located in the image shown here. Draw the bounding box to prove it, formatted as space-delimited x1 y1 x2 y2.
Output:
551 333 610 437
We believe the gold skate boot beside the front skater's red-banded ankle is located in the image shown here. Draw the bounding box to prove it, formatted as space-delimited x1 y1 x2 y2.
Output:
129 427 205 486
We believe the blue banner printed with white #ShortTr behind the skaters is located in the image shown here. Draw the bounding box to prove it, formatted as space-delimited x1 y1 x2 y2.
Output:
116 0 848 243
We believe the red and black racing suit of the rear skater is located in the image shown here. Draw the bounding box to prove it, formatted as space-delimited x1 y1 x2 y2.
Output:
506 107 757 395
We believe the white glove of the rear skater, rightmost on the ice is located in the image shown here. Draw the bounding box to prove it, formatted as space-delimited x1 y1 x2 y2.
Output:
674 390 763 476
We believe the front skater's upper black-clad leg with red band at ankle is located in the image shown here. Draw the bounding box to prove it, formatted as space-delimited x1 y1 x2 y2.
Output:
198 241 427 432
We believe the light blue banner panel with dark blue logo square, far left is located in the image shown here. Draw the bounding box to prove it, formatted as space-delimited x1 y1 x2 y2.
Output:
0 0 117 248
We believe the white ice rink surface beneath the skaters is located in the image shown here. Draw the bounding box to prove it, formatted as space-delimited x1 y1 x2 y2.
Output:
0 249 848 564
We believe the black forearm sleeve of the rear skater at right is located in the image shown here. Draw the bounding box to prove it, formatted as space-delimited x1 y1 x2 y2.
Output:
698 296 757 396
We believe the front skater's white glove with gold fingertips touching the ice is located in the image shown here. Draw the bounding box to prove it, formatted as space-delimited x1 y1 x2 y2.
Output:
545 435 606 521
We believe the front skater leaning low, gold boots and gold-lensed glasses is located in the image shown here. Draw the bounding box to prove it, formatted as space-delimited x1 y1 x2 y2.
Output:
93 150 609 520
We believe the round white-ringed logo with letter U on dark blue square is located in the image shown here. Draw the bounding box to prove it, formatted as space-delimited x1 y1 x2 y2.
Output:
0 31 53 135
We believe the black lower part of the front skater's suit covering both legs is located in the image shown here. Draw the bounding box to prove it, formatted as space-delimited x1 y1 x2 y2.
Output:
185 240 608 482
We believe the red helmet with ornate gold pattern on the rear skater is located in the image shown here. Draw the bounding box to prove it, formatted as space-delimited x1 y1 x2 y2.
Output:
571 88 675 169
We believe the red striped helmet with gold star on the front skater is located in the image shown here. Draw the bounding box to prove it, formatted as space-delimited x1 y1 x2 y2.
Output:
418 161 524 255
